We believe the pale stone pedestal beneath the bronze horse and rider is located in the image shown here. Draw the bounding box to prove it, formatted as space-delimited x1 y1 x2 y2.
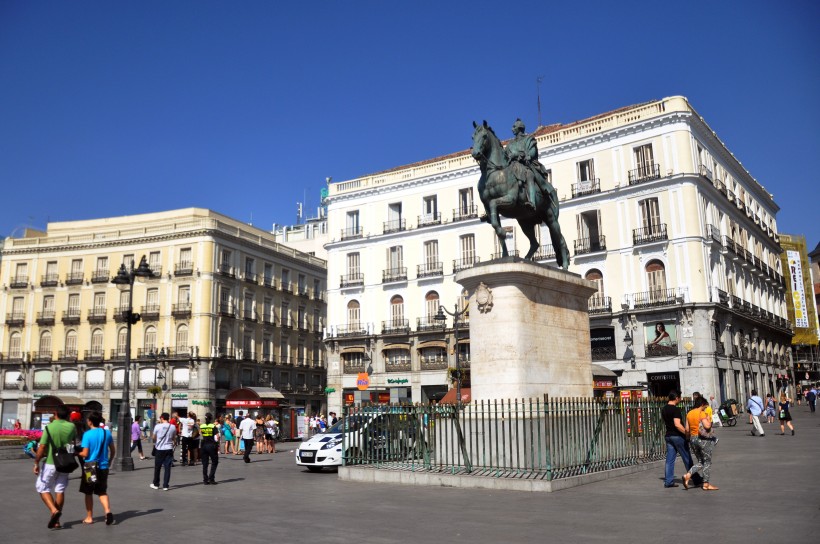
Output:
456 257 596 401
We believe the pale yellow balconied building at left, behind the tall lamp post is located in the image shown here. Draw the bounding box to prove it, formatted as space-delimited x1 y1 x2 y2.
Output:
0 208 326 427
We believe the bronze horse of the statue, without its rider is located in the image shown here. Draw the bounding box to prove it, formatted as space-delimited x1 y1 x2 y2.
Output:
471 121 569 270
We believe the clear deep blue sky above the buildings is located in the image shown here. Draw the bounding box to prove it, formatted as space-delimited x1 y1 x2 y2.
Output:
0 0 820 247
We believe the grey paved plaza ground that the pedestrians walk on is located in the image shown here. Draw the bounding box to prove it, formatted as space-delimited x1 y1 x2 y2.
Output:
0 406 820 544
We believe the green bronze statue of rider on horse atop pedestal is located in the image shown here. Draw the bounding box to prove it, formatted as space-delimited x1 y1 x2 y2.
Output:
471 119 569 270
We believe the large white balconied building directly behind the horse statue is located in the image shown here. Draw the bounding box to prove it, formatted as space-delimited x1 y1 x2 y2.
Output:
326 97 791 410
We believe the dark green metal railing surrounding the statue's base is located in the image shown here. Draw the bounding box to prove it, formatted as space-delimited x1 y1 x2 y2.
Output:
343 398 687 480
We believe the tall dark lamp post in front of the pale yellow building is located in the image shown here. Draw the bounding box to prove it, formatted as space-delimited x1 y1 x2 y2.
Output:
111 255 154 472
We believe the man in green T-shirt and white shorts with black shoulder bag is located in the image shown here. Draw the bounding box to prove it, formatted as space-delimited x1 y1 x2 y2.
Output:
34 405 77 529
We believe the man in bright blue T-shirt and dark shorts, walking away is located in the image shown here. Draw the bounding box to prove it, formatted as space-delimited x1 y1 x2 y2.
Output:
80 412 116 525
